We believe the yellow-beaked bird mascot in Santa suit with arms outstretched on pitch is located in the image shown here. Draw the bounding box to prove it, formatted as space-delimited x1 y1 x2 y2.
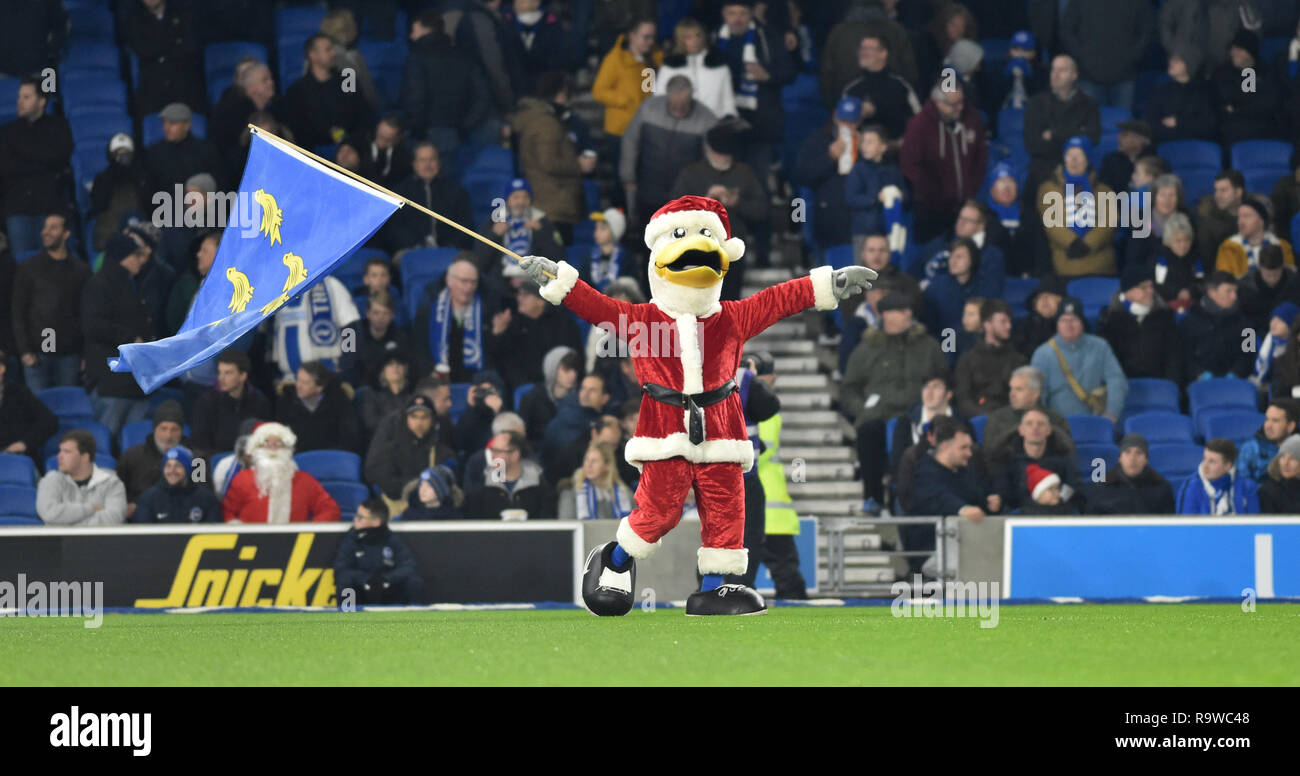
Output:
520 196 876 616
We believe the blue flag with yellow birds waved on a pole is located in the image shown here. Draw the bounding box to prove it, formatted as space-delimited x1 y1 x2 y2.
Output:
108 131 402 393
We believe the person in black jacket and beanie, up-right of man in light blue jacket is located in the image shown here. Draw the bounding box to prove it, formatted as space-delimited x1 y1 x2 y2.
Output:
1097 258 1183 382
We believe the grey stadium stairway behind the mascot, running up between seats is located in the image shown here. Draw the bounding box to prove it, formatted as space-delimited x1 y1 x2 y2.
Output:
742 266 900 589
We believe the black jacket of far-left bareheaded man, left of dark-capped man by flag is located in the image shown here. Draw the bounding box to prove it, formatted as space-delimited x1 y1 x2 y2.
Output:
13 251 89 363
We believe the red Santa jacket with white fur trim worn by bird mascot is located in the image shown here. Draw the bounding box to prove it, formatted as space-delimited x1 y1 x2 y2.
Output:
545 261 837 469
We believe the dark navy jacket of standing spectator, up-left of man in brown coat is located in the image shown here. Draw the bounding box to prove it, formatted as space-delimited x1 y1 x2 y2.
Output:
402 32 491 139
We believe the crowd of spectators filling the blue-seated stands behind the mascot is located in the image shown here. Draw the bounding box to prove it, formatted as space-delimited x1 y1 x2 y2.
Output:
0 0 1300 525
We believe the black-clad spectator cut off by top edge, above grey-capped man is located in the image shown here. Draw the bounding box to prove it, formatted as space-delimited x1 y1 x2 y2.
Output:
117 0 208 117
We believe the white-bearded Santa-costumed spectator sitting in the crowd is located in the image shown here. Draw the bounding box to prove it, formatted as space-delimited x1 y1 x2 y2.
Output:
221 422 339 523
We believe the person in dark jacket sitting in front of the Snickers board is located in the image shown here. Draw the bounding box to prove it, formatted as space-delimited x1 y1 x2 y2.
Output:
334 498 424 606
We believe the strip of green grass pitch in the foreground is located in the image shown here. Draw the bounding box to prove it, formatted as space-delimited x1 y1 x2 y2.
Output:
0 604 1300 685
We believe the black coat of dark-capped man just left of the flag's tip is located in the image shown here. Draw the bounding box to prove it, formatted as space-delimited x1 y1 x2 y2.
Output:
82 259 155 399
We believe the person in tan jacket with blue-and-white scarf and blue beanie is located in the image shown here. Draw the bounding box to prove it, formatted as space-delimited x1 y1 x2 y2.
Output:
1026 130 1117 278
